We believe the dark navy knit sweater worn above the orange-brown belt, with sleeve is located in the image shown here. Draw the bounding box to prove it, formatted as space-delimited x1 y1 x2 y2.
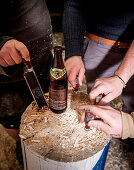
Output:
63 0 134 59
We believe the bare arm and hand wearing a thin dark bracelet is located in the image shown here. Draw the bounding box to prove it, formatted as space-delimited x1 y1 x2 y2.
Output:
89 41 134 105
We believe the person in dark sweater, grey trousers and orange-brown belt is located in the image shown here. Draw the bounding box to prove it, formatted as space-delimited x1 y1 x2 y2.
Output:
63 0 134 113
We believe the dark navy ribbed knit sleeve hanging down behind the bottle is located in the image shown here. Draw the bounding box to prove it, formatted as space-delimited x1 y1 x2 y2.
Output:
63 0 86 60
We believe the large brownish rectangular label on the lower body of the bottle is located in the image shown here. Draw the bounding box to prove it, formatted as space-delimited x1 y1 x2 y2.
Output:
49 88 67 110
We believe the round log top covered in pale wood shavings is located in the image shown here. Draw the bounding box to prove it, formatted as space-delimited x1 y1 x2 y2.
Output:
20 91 110 162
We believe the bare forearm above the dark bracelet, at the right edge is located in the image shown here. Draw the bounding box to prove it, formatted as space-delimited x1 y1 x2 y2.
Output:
115 41 134 83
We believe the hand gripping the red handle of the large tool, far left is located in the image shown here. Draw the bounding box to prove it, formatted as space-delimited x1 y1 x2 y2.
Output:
0 40 30 67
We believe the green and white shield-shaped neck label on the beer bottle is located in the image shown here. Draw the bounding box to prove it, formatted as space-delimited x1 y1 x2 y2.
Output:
50 68 66 80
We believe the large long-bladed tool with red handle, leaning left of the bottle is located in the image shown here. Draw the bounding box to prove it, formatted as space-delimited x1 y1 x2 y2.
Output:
18 51 48 108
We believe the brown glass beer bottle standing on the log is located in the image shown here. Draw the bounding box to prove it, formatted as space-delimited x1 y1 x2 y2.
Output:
49 46 68 113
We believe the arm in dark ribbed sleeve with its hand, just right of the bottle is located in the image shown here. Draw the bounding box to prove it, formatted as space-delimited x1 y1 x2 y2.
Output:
63 0 85 86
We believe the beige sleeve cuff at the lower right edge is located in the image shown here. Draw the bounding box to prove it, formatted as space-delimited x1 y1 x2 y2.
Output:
122 112 134 139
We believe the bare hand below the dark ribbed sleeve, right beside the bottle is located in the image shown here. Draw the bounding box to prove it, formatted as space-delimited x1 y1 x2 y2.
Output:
65 56 85 87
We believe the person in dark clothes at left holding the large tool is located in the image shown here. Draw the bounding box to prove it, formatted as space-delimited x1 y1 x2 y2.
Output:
0 0 52 165
